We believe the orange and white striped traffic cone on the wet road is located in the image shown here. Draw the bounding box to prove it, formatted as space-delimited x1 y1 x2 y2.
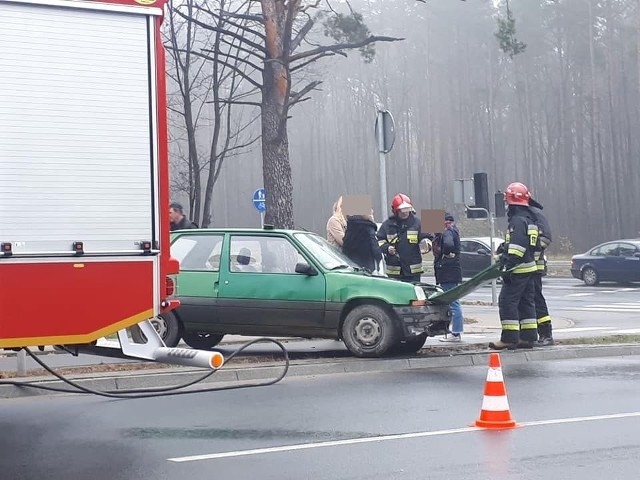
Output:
476 353 516 430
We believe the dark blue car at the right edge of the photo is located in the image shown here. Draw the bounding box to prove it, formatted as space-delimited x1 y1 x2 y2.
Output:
571 239 640 286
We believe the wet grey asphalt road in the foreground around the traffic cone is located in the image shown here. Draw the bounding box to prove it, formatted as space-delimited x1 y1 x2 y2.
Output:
0 354 640 480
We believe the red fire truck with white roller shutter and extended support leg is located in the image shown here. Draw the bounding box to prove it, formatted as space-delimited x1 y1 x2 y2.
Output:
0 0 220 366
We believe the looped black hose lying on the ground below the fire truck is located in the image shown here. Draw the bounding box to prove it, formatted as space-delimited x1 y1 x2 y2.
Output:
0 338 290 398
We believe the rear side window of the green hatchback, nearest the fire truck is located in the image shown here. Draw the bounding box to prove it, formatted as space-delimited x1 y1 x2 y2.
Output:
171 235 224 272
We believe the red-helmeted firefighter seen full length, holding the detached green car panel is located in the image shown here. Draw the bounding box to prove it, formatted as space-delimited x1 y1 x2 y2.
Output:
489 182 538 350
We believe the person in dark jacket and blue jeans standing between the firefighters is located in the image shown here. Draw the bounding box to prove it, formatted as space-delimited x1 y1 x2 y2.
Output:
432 214 464 343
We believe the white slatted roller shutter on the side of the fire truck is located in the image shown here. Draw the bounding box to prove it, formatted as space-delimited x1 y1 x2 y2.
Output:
0 1 157 254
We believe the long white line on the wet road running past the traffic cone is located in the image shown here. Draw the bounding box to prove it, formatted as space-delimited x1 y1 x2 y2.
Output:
167 412 640 463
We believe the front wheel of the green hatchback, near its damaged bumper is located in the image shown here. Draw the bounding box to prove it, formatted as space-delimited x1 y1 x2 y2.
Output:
342 305 398 357
